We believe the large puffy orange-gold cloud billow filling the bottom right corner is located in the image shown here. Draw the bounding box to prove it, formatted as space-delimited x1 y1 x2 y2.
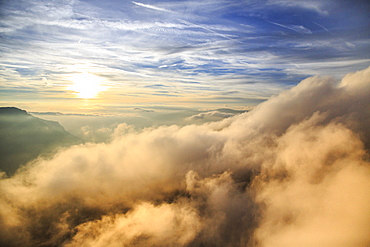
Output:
254 114 370 246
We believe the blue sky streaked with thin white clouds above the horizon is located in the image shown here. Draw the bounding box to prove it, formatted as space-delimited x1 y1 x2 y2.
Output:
0 0 370 113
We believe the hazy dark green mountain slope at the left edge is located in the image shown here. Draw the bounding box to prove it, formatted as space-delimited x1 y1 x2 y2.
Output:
0 107 81 176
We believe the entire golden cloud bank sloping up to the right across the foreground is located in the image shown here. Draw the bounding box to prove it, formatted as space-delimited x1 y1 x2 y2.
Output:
0 68 370 247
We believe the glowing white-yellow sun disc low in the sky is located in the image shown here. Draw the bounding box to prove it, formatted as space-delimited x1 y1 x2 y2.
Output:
68 72 105 99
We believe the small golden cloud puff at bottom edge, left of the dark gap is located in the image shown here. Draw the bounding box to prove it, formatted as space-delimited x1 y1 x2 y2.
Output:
67 203 201 247
